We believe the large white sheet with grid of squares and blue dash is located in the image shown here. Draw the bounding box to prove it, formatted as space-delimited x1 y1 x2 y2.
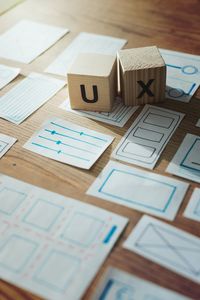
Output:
0 175 128 300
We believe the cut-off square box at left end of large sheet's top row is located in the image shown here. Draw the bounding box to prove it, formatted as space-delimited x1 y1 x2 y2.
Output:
0 187 26 215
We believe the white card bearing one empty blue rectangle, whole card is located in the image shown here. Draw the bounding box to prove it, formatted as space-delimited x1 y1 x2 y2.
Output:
87 161 189 220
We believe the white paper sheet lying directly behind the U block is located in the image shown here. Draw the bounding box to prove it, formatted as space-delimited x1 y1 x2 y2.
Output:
45 32 127 76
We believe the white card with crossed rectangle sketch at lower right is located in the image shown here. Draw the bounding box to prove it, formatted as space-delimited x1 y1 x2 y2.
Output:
123 216 200 283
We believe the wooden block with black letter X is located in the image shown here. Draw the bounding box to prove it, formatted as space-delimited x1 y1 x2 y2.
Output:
118 46 166 106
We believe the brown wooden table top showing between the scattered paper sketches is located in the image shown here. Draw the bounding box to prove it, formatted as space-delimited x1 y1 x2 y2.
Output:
0 0 200 300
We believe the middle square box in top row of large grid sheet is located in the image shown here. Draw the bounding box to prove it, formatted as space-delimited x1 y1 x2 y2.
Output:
23 199 64 231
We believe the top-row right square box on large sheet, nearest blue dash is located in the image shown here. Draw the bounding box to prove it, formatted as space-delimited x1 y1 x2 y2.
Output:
62 212 104 247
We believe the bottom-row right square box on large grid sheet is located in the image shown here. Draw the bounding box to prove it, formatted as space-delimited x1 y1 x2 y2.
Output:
34 250 80 292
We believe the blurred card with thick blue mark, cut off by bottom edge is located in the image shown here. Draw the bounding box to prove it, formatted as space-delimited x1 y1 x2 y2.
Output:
92 268 189 300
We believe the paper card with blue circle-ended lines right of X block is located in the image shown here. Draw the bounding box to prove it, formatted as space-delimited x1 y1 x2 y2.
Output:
159 49 200 102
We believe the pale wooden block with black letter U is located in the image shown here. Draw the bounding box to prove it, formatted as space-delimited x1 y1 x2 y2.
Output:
67 53 117 112
